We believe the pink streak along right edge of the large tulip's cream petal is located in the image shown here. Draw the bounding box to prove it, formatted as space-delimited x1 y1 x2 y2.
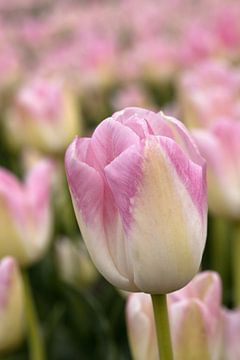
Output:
159 136 207 219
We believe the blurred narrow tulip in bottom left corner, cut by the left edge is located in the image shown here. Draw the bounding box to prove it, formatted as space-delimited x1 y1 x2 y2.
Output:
0 257 25 352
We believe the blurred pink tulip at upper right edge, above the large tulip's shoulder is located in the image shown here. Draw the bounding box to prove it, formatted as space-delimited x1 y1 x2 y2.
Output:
179 61 240 128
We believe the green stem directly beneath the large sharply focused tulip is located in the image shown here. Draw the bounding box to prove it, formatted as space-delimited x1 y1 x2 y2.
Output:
151 295 173 360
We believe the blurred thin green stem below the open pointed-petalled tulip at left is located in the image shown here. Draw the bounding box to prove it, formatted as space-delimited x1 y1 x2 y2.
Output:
23 271 45 360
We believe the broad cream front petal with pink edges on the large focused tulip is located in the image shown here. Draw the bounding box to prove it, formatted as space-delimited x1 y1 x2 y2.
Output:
107 138 206 293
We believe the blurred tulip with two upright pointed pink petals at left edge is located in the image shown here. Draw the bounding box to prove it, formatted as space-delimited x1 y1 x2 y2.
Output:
0 160 53 265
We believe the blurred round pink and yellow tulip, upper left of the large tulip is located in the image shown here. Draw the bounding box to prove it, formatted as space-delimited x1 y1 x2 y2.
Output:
6 79 81 152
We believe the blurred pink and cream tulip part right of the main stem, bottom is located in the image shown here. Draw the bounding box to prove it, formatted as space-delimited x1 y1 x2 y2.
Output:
168 271 222 360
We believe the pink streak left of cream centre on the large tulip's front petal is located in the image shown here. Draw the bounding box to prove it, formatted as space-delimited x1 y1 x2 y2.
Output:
105 144 143 231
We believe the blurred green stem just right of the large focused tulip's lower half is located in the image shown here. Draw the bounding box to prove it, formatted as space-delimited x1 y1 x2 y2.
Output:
211 218 230 301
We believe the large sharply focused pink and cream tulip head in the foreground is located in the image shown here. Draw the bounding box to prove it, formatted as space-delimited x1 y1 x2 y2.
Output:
65 108 207 294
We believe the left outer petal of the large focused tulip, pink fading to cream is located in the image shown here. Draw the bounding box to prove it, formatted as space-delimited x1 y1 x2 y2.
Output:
65 140 136 290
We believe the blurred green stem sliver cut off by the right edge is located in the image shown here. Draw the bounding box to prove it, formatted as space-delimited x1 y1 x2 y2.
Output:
232 222 240 306
